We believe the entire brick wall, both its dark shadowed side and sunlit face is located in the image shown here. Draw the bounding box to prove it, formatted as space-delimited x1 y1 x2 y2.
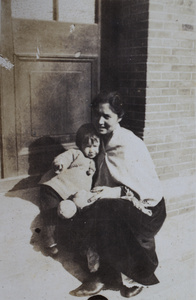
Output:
101 0 196 215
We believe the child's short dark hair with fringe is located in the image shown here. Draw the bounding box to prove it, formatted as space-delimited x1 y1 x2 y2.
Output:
76 123 99 150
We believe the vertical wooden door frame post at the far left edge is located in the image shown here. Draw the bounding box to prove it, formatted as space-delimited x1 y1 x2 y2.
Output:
0 0 17 178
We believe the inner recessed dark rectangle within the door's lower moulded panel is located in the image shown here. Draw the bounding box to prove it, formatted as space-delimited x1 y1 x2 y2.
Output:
30 66 91 137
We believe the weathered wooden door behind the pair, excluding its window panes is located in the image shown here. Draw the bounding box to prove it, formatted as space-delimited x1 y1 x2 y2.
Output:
1 0 99 177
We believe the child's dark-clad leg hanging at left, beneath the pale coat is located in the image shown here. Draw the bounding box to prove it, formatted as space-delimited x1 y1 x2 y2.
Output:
40 185 62 254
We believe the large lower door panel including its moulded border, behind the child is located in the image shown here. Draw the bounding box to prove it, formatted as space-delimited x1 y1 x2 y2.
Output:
15 57 97 174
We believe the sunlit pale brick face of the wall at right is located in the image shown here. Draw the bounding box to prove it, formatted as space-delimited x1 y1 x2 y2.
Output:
144 0 196 213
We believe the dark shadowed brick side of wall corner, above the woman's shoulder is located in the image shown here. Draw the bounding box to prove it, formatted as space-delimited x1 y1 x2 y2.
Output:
118 0 149 137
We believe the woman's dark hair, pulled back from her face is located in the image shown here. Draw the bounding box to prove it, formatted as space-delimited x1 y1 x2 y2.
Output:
92 91 124 118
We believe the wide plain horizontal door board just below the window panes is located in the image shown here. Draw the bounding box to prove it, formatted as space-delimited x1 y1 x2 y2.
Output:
13 19 99 57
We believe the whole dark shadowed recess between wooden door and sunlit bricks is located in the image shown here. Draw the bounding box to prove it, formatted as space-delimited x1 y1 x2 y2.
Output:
101 0 148 137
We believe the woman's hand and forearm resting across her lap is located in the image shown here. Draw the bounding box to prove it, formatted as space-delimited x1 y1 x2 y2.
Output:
88 186 121 203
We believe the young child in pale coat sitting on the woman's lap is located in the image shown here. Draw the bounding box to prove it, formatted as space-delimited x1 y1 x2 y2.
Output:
40 124 100 254
